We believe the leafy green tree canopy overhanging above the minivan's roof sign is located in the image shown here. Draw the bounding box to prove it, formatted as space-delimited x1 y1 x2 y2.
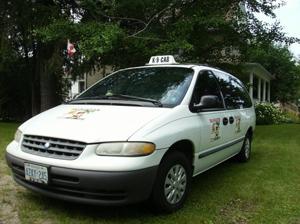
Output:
36 0 295 68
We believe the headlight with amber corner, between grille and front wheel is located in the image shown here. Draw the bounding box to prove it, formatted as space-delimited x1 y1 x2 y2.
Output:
96 142 155 156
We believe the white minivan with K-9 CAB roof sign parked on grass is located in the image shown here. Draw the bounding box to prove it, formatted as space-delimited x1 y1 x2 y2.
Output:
6 56 255 212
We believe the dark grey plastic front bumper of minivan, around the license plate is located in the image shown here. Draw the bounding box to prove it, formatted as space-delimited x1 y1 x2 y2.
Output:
6 153 158 205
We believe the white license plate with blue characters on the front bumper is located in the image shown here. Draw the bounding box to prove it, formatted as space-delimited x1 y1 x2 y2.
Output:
24 163 48 184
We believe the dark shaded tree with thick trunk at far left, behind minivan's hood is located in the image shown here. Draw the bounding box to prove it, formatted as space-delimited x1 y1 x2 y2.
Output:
1 0 65 117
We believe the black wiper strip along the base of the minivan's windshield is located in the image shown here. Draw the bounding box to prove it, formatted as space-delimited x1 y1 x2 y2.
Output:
67 94 163 107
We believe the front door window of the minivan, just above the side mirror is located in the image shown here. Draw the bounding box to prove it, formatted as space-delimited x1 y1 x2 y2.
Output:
192 70 224 109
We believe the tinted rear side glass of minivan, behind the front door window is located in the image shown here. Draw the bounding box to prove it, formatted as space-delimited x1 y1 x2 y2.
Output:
214 71 252 110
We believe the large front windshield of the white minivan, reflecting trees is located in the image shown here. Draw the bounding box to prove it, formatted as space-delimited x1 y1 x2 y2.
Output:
75 67 194 107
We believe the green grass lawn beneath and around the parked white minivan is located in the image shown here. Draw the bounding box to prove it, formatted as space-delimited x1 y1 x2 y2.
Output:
0 123 300 224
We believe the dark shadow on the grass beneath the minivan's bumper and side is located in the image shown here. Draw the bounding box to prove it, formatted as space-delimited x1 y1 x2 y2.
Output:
18 160 246 221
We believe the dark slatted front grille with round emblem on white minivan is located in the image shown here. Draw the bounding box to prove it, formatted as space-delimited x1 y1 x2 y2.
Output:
22 135 86 160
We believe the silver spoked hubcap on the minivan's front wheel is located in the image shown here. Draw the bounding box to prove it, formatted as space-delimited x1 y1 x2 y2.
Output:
164 164 186 204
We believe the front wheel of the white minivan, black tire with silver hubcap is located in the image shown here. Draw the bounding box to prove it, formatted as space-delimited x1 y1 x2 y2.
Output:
151 151 192 213
